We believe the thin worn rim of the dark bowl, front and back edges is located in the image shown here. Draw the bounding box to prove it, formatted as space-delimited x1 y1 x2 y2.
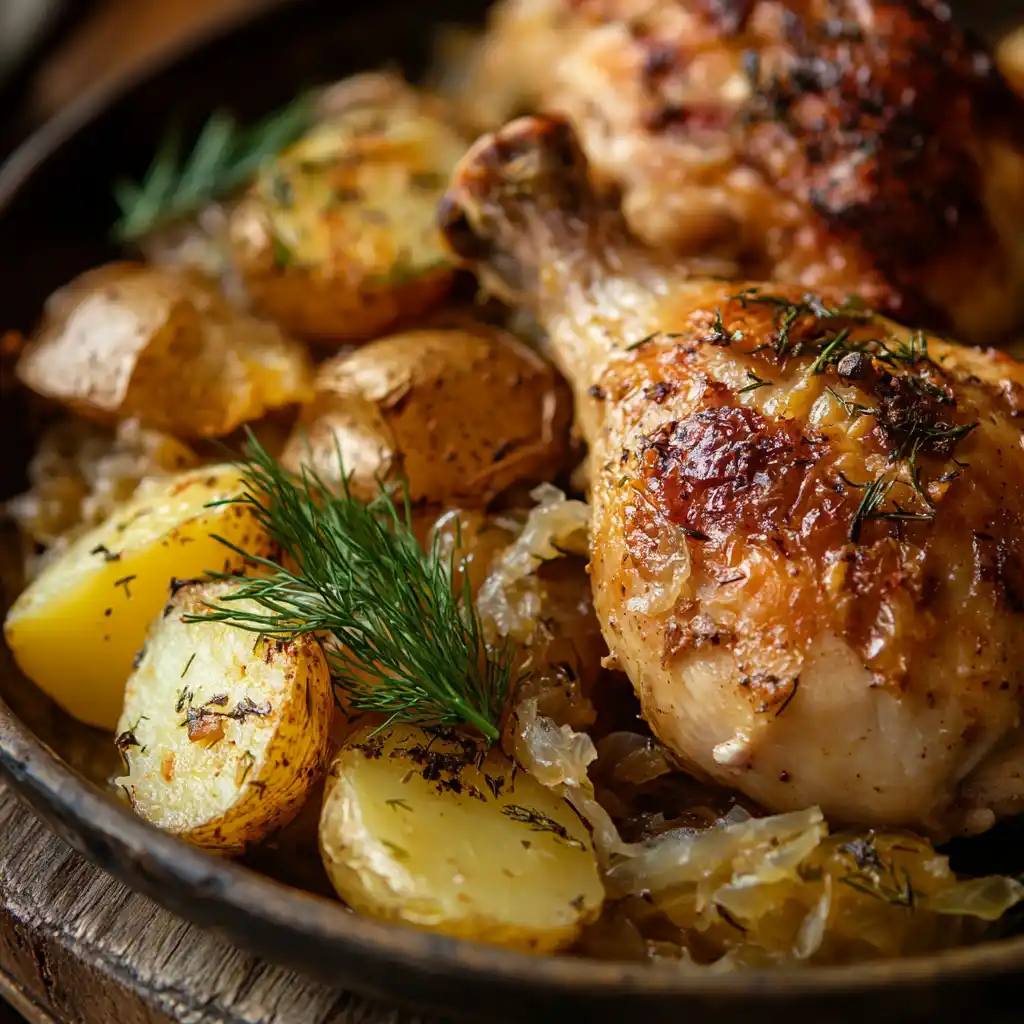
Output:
0 0 1024 1004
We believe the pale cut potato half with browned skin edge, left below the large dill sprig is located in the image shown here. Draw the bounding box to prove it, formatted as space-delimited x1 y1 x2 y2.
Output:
116 582 334 854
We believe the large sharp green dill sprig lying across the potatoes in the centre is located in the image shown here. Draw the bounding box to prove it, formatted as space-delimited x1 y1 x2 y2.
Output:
189 434 512 741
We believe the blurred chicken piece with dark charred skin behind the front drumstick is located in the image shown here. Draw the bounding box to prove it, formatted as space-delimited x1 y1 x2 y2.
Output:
464 0 1024 342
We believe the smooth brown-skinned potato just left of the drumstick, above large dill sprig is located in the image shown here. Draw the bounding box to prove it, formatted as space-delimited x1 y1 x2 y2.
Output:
282 326 571 508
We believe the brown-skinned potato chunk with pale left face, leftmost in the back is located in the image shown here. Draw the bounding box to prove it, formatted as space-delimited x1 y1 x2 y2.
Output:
16 262 312 438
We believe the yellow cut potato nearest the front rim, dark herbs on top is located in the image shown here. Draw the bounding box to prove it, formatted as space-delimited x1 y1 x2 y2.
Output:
319 725 604 952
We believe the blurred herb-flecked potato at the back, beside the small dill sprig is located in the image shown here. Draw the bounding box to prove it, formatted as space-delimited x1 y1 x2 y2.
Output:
227 74 467 344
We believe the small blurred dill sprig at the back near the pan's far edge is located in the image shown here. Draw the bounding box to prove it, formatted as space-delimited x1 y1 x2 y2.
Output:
114 95 315 242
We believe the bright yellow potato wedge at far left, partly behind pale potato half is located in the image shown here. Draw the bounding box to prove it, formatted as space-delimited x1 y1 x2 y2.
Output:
4 465 271 729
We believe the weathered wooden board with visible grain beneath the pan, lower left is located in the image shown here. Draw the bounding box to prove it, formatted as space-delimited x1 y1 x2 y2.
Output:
0 784 452 1024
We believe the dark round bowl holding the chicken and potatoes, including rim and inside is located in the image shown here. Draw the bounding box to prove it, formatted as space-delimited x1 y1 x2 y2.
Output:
0 0 1024 1024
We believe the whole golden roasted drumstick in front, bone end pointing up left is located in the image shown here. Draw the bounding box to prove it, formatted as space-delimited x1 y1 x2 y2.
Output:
440 117 1024 837
